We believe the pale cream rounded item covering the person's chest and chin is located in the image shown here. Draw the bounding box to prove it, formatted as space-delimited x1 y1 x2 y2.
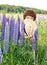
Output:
24 19 37 36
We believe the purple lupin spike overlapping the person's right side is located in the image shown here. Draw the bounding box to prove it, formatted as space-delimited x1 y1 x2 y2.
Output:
32 17 40 51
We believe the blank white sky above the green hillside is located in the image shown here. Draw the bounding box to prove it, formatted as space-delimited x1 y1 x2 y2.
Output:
0 0 47 10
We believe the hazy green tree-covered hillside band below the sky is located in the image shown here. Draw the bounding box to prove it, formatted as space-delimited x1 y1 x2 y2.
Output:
0 5 47 14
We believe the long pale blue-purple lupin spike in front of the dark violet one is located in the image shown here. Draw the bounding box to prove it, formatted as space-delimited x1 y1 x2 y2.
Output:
4 22 9 53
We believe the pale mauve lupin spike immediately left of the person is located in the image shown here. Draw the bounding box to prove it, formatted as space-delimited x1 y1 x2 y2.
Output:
19 21 25 45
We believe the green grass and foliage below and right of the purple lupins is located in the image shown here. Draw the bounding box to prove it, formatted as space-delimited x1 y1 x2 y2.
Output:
0 13 47 65
